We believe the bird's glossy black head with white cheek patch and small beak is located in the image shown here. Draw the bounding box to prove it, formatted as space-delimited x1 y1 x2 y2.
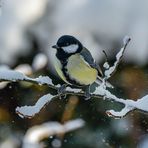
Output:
52 35 83 55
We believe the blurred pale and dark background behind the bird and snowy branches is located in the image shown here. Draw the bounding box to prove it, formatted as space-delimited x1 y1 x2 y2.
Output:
0 0 148 148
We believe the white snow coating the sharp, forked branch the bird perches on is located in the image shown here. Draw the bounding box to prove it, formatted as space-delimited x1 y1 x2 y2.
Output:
0 37 148 118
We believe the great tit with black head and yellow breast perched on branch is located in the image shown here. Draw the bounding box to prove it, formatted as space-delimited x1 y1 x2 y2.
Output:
52 35 107 99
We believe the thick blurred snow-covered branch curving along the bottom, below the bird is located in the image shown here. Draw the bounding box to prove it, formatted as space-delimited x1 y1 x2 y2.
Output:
23 119 85 148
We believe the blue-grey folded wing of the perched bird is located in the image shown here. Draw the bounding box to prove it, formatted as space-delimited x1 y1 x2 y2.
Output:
80 47 103 76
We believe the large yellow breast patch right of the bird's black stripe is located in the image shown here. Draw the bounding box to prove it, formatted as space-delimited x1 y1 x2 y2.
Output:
67 54 98 85
